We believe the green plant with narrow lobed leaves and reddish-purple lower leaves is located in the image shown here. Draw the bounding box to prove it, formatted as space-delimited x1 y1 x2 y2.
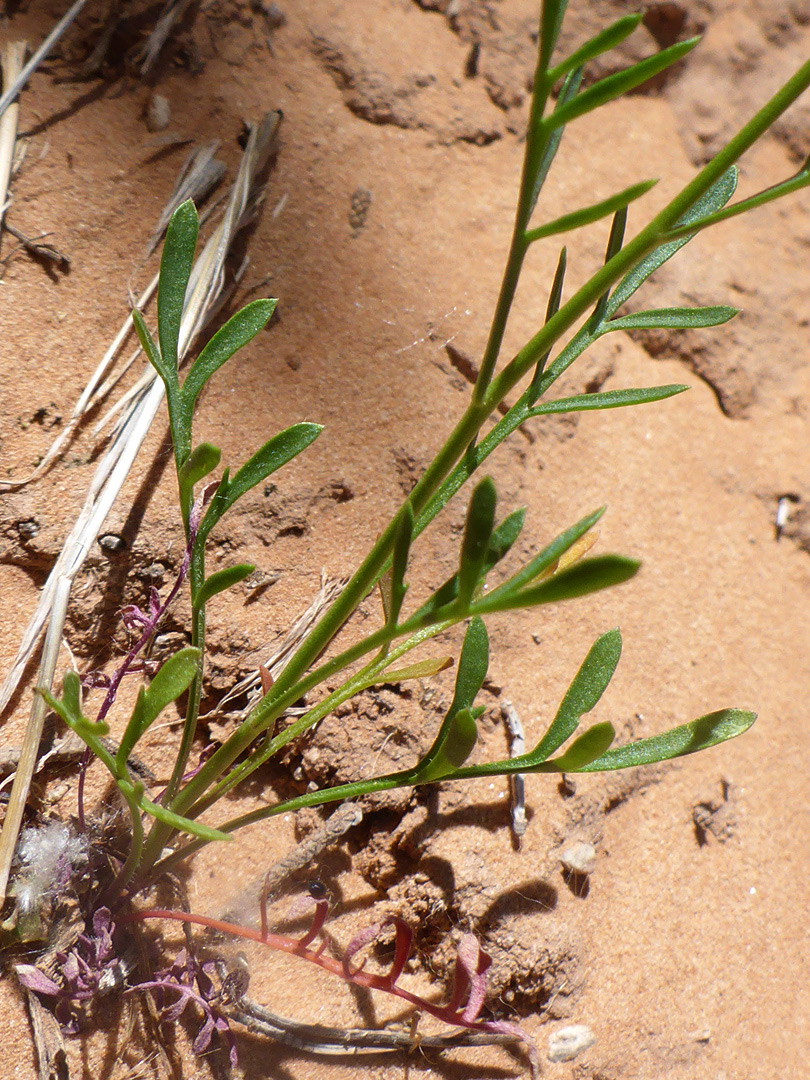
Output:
9 0 810 1071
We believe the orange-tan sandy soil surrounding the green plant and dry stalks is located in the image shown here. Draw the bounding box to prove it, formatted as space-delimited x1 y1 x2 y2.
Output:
0 0 810 1080
